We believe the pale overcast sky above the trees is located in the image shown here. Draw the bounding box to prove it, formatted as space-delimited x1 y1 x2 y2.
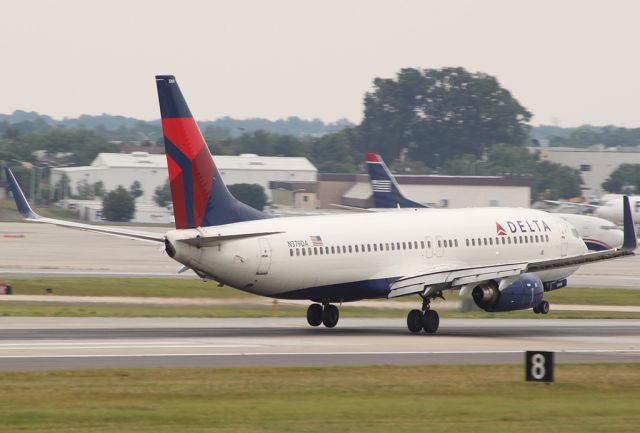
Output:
0 0 640 127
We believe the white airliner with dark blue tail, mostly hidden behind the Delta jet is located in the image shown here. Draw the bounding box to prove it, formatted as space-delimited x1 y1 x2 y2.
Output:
364 153 624 251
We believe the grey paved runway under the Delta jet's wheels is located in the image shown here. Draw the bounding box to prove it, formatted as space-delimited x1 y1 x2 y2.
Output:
0 317 640 370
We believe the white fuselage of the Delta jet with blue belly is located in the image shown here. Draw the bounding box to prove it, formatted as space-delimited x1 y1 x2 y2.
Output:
167 208 587 301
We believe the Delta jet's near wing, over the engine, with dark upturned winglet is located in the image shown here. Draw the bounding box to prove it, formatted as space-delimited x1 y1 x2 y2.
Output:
388 196 637 298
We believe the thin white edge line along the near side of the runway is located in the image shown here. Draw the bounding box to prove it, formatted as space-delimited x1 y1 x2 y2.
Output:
0 349 640 359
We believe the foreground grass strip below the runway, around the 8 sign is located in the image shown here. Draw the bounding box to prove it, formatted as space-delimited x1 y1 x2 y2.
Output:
0 364 640 433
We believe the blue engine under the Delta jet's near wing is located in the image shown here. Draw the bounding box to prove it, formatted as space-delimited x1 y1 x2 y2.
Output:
471 274 544 312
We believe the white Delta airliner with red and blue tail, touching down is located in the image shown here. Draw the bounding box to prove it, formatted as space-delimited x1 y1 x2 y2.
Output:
5 75 636 334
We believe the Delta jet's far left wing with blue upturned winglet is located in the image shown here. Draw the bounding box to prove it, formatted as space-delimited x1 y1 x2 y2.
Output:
4 167 164 242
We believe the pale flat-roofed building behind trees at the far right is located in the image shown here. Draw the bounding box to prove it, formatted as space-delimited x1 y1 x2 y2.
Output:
529 147 640 197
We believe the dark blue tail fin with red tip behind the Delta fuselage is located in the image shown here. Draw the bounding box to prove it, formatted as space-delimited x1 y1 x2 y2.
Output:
366 152 428 208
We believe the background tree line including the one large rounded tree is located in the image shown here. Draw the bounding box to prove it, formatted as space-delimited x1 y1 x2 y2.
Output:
0 68 608 204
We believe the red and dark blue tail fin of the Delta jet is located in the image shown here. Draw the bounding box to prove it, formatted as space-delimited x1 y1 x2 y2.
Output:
156 75 268 229
